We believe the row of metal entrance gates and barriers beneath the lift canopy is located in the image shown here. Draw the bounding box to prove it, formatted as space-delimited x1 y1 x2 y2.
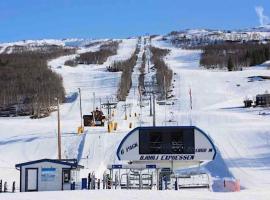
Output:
108 164 211 190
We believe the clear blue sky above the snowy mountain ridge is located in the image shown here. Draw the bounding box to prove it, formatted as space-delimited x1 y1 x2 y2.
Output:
0 0 270 42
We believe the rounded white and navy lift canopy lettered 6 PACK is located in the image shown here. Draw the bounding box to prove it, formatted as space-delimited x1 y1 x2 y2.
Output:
117 126 216 167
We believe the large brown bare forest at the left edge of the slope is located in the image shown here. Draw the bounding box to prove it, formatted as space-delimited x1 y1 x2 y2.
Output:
0 45 75 117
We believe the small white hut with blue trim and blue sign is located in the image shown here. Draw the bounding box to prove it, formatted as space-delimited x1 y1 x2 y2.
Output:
16 159 83 192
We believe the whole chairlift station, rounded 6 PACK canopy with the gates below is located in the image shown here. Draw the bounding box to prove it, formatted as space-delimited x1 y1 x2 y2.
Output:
108 126 216 189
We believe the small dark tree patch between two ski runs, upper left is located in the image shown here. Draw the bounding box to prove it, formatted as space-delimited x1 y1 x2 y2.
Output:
65 41 119 66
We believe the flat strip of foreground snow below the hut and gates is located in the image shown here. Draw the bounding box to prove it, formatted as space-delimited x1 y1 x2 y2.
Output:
0 190 269 200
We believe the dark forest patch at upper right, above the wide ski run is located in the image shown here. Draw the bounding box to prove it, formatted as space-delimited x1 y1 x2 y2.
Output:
200 42 270 71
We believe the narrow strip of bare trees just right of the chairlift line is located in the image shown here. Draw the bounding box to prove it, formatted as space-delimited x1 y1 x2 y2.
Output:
150 46 173 100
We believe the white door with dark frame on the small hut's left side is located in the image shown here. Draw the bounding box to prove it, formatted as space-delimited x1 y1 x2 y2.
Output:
25 168 38 192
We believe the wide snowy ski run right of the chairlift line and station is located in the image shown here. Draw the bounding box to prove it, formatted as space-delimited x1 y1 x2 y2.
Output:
151 38 270 189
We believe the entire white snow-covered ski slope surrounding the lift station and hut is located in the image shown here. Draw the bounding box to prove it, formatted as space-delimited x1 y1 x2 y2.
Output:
0 38 270 199
